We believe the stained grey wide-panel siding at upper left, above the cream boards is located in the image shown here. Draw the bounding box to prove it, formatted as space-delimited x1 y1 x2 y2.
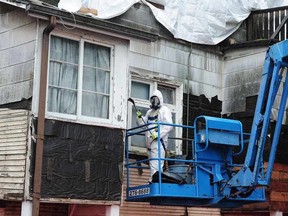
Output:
0 4 36 104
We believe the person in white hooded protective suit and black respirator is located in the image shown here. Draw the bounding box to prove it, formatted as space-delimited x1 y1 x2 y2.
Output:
136 90 173 182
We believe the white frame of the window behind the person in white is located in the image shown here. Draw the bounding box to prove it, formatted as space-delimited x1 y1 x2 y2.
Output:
128 76 183 155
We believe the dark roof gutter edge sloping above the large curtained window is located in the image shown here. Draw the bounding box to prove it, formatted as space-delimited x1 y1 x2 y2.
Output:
26 3 159 41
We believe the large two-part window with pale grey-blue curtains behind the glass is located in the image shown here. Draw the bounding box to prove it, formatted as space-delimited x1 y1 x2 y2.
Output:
47 35 113 121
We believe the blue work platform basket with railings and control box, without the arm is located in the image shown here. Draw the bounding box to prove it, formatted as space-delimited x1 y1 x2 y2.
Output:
126 116 265 208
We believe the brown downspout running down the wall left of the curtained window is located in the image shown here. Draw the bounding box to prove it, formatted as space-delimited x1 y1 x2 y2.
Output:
32 16 56 216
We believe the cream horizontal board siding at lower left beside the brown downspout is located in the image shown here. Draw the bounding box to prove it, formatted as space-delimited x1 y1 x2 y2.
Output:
0 109 28 200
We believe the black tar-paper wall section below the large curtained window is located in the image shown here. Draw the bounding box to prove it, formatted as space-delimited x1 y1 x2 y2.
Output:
38 120 124 204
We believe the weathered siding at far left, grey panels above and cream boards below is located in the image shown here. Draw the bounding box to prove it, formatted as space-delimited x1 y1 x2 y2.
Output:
0 4 36 200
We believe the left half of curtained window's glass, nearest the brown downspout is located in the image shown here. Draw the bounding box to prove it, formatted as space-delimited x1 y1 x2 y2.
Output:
47 36 79 115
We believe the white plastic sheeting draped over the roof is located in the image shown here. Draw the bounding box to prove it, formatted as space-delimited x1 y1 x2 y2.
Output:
58 0 288 45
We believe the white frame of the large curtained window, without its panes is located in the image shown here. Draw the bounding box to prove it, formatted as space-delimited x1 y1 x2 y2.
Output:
46 33 115 124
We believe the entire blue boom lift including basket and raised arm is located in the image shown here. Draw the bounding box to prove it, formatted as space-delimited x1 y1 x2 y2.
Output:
126 40 288 208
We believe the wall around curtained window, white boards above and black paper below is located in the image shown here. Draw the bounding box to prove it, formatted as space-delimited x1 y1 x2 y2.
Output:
26 20 128 202
